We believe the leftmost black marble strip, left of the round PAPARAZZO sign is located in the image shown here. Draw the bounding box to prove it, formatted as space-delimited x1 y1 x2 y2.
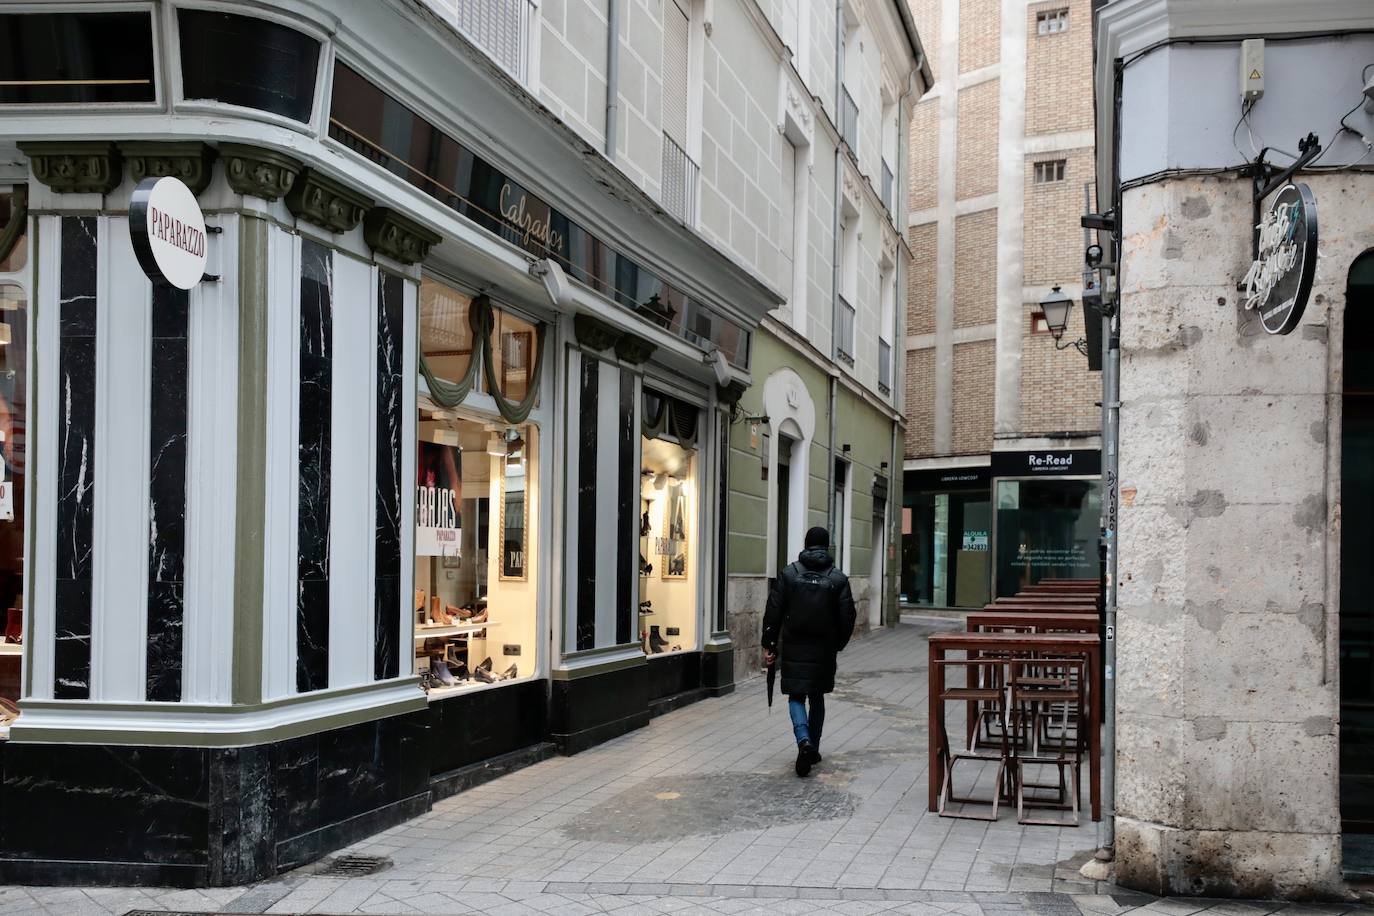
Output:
52 216 96 699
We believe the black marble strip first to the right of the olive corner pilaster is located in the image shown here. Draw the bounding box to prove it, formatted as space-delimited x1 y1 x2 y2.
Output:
295 239 334 694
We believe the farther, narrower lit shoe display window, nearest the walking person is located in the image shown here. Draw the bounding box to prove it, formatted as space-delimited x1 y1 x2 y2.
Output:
639 433 698 656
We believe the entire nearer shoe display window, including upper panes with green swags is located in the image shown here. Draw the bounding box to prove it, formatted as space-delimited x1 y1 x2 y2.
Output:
414 271 539 698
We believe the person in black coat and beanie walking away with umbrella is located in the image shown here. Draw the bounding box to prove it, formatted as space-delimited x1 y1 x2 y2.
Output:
761 527 856 776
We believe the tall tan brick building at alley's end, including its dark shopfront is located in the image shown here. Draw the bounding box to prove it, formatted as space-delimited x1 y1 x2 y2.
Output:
901 0 1101 607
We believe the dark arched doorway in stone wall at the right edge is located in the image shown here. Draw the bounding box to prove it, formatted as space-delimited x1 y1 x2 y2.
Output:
1340 249 1374 875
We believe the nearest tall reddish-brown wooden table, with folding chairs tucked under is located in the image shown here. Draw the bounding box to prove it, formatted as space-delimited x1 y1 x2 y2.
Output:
926 633 1102 821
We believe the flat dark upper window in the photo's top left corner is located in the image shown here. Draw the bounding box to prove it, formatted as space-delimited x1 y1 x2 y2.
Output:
0 11 157 104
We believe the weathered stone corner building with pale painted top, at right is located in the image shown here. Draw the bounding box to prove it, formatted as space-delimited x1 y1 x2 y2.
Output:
1096 0 1374 900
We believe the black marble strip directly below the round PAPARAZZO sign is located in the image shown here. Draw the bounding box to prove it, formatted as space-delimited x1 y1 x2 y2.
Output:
146 284 188 700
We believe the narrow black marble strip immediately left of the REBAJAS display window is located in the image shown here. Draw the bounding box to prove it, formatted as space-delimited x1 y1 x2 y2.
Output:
372 271 405 680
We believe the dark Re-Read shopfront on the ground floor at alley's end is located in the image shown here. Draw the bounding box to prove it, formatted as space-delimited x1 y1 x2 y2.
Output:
901 444 1102 608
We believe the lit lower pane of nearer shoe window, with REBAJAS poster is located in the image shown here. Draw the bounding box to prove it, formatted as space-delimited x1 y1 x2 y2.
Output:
415 411 539 696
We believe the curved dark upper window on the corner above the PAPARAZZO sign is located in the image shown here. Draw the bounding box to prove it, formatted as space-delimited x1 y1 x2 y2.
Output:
177 10 320 121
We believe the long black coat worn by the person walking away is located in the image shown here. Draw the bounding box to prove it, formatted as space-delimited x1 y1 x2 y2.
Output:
763 547 856 696
